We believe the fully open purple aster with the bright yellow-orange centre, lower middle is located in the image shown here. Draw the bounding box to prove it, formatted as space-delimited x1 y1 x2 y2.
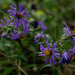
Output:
39 39 60 65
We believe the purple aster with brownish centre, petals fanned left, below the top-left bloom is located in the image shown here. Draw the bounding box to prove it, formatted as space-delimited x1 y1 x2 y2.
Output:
9 25 29 40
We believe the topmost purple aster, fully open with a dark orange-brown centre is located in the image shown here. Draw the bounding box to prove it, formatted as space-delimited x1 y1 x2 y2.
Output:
7 3 30 28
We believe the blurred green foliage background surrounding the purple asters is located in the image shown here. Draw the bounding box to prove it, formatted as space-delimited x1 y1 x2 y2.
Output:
0 0 75 75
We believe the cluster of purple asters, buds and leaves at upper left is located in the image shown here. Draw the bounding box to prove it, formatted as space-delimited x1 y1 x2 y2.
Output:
0 3 30 40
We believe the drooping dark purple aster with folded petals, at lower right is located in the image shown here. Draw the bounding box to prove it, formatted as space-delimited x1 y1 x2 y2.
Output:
58 52 72 64
